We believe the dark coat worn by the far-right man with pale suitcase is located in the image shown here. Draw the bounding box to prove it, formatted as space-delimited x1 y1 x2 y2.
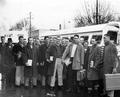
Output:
103 42 117 74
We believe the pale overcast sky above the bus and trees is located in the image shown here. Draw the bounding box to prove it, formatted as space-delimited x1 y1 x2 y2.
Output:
0 0 120 29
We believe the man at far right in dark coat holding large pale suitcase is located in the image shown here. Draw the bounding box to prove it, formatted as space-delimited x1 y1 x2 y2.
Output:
103 34 117 97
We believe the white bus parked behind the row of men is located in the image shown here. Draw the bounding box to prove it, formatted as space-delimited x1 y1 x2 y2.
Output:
40 22 120 46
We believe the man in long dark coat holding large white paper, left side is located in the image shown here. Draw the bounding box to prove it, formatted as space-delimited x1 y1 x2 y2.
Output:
24 37 38 87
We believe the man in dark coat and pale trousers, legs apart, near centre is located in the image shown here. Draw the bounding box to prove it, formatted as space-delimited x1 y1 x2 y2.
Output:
47 37 63 96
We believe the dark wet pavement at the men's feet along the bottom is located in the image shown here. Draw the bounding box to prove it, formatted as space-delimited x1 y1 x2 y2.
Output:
0 84 120 97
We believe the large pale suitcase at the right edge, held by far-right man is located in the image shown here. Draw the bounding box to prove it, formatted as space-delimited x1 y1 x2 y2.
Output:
105 73 120 91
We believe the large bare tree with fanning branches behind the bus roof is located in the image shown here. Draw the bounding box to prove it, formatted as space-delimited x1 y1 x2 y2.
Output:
74 0 115 27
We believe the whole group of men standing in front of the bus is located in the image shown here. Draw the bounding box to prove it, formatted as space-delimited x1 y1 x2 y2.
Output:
0 34 118 95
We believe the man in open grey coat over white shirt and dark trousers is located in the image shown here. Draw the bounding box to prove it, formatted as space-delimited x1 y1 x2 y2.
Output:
62 35 84 92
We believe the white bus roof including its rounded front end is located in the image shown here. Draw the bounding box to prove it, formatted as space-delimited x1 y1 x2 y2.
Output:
40 23 118 37
